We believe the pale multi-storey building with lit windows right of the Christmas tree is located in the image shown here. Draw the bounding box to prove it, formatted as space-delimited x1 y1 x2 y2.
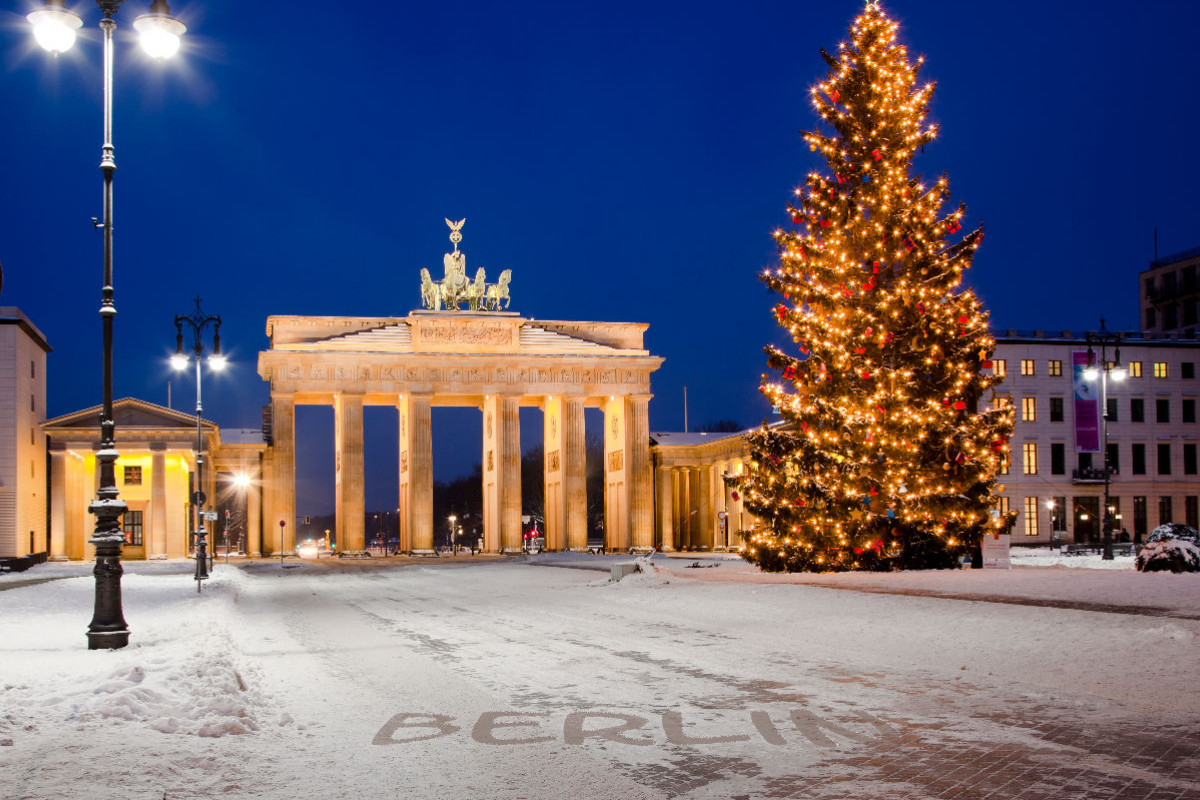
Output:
991 331 1200 543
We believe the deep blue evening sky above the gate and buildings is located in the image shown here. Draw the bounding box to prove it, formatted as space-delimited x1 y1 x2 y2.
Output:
7 0 1200 513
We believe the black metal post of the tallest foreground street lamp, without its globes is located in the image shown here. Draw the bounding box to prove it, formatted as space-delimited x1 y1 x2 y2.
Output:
88 6 130 650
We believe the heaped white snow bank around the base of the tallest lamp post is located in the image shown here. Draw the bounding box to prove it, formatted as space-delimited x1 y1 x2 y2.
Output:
0 569 265 746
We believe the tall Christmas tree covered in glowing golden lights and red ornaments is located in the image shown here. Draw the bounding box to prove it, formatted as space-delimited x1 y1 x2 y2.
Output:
740 2 1014 571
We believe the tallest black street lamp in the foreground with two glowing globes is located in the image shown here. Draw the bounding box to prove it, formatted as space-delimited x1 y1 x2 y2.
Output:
25 0 187 650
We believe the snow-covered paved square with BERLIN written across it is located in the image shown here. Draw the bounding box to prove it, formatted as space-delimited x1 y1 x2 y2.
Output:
0 552 1200 800
